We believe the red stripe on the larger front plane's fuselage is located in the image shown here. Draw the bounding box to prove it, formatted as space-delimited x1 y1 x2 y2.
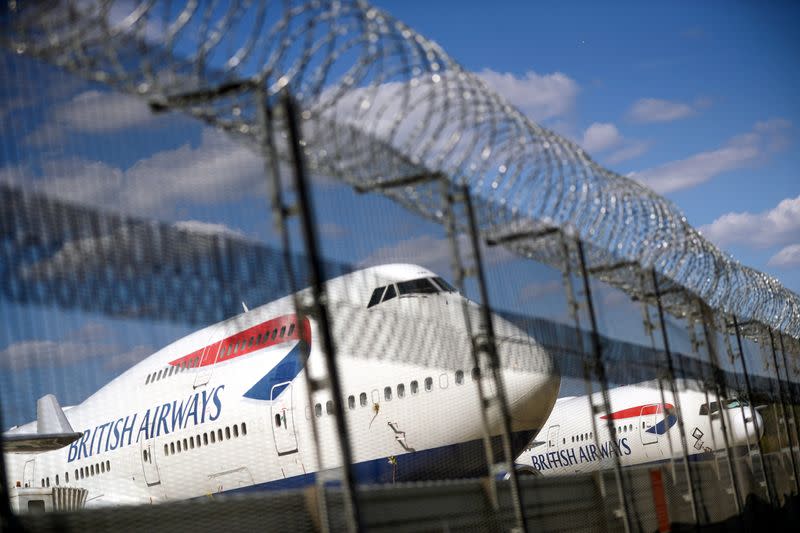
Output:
169 315 311 368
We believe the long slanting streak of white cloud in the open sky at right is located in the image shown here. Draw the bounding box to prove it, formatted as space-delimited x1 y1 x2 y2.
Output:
632 119 791 194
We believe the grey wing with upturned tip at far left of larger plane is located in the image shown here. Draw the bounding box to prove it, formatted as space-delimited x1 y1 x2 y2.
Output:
2 394 83 453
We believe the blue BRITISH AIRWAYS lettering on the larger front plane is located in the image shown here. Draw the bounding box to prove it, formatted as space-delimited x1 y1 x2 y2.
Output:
67 385 225 463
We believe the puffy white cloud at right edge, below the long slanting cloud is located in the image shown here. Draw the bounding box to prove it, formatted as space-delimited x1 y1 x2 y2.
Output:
700 196 800 248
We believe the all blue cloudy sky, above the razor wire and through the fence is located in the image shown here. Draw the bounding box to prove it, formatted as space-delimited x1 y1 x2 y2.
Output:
0 1 800 422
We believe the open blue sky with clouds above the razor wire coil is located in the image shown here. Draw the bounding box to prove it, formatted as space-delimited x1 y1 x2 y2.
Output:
376 0 800 292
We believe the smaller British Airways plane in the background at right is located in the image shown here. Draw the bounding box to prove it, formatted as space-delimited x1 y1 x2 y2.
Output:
515 380 764 475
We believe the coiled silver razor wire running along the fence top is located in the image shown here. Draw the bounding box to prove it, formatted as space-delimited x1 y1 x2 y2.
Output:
4 0 800 339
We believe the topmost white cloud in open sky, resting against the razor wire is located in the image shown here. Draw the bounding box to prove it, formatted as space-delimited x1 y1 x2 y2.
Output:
478 69 579 120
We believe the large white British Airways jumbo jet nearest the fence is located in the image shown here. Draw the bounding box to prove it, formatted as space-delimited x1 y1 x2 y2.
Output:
4 264 560 507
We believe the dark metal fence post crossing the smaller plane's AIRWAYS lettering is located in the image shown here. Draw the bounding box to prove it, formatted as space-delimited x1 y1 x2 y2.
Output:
576 239 631 533
